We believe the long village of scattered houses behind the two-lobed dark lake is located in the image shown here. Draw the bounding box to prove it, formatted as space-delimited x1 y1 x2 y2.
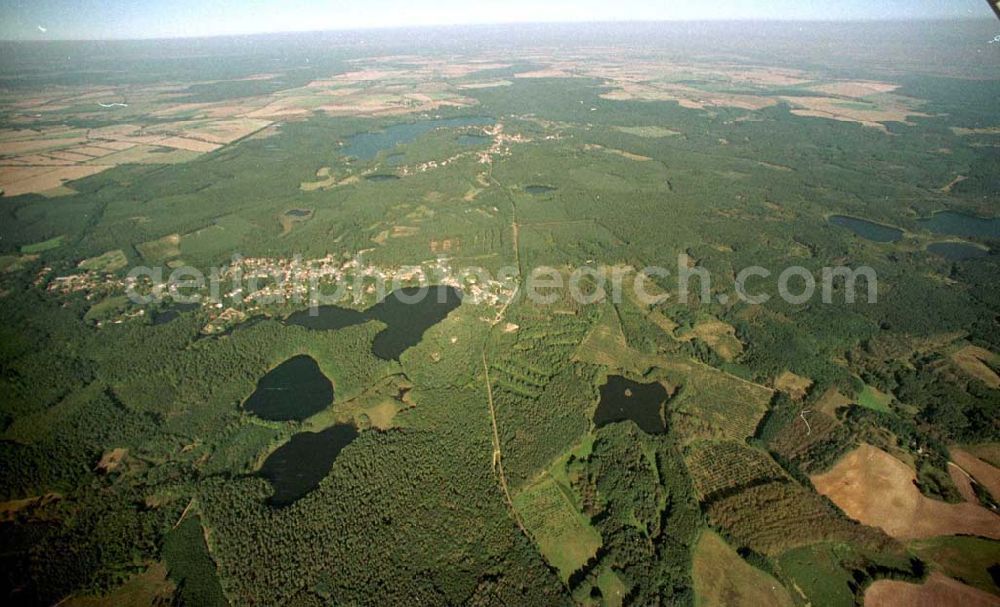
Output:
43 252 517 334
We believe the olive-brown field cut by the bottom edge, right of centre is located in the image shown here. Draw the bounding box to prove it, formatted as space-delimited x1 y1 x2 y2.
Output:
691 531 794 607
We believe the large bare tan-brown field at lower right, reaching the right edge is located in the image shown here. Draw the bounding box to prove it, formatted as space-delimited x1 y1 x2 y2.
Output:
810 445 1000 539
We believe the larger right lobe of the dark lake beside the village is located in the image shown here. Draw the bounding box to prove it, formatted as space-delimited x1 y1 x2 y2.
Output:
368 286 462 360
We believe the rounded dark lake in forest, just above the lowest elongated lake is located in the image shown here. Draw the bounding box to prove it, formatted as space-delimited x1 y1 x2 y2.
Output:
243 355 333 421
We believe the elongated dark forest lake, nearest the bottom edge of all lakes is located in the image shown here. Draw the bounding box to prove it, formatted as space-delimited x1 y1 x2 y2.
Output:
260 424 358 507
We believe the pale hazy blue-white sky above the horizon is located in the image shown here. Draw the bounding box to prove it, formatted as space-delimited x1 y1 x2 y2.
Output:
0 0 992 40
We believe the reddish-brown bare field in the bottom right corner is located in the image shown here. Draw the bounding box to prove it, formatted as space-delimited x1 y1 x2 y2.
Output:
865 572 1000 607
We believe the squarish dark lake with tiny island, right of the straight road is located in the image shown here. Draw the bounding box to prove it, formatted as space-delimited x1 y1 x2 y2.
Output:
594 375 667 434
